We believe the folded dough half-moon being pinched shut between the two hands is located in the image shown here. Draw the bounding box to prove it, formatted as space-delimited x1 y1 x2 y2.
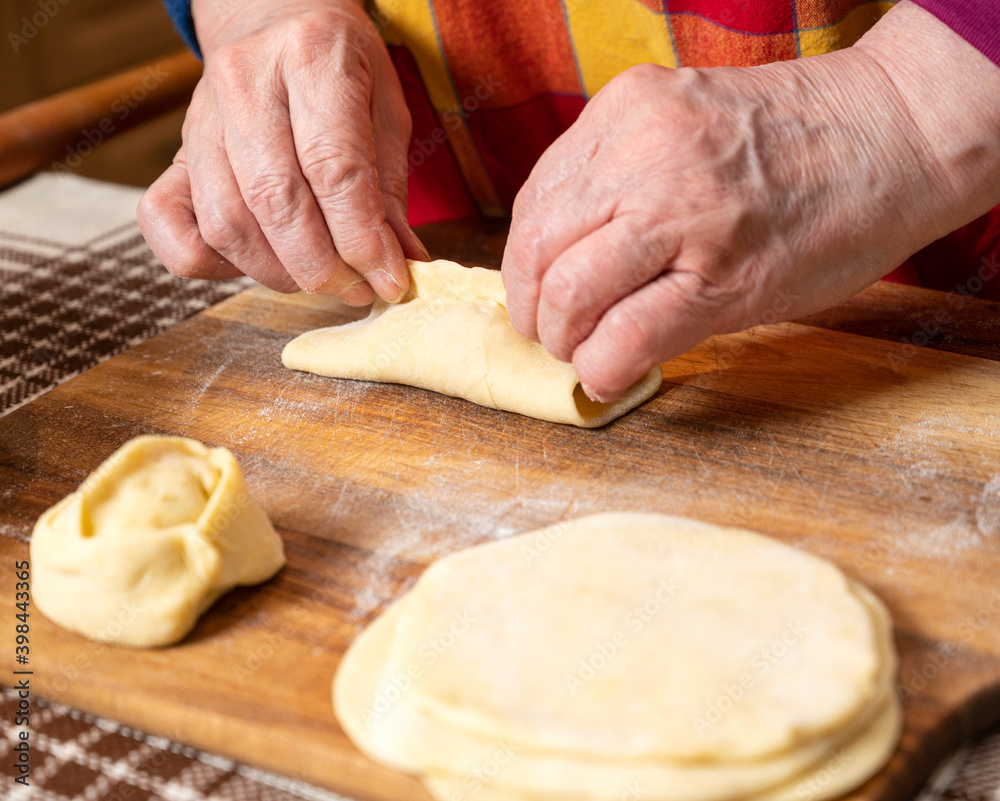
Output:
281 260 663 428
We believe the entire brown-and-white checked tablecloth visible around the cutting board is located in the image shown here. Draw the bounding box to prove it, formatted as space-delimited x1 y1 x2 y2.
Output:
0 175 1000 801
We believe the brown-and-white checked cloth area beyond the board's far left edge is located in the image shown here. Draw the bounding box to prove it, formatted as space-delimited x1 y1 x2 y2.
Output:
0 174 249 415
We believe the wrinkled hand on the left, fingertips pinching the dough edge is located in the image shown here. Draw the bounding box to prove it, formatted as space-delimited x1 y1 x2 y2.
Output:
139 0 427 305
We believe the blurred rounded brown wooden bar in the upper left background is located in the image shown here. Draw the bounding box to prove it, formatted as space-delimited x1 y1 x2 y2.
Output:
0 50 201 186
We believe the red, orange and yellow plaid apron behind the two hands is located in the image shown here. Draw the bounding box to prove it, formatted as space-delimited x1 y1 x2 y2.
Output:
388 0 1000 299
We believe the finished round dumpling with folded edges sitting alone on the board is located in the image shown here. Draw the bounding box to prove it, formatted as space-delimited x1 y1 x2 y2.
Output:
31 436 285 646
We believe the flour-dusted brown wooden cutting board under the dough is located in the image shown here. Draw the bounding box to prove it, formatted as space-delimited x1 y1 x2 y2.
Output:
0 223 1000 801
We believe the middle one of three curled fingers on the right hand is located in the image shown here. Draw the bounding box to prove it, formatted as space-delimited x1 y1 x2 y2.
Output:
537 213 680 362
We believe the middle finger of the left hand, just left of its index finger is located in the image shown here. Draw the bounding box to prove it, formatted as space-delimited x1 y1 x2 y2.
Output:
223 76 373 306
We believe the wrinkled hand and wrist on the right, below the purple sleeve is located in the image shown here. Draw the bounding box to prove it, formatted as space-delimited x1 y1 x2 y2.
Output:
502 4 1000 401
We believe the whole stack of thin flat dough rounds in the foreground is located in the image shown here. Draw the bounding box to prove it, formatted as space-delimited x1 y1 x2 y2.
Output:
333 513 901 801
